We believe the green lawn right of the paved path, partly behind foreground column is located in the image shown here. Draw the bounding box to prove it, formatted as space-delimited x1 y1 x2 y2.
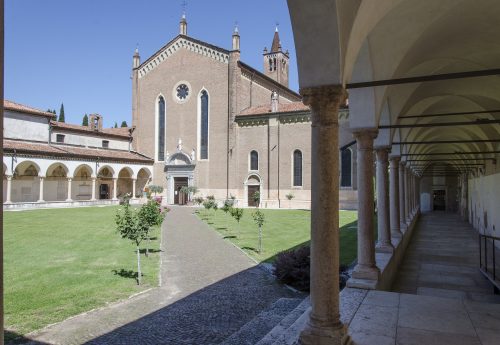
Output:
197 209 358 265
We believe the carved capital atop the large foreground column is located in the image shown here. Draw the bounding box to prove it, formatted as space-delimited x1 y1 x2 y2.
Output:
300 85 347 126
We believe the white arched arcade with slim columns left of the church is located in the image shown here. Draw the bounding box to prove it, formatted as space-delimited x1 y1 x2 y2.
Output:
3 156 152 205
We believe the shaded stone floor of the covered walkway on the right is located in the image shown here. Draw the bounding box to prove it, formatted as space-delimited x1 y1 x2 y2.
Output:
393 212 500 303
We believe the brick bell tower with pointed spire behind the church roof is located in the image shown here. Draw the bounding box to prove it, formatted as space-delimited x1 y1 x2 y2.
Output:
263 26 290 87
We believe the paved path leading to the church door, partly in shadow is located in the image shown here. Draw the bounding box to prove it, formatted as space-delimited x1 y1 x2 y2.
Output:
21 207 297 345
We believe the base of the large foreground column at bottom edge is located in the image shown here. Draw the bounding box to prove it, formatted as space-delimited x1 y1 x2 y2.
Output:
299 323 354 345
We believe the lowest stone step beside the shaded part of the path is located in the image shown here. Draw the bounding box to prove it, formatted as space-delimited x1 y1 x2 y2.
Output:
221 298 302 345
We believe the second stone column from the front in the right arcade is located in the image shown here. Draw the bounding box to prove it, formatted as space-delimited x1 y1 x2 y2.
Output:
352 129 380 281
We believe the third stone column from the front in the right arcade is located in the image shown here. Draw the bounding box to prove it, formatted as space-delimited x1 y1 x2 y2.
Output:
375 147 394 253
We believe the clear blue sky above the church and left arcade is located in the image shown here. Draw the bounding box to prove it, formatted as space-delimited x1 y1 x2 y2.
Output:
5 0 298 127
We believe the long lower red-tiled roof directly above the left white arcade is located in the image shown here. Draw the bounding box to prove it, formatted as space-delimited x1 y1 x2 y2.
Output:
3 139 153 164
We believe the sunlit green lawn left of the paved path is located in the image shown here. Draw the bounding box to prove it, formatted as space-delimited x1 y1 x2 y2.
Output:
3 206 160 334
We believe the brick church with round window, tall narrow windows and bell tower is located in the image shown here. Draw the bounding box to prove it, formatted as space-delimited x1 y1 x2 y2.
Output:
132 16 356 208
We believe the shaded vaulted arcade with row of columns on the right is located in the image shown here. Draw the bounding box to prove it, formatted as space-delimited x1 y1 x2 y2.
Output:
287 0 500 345
